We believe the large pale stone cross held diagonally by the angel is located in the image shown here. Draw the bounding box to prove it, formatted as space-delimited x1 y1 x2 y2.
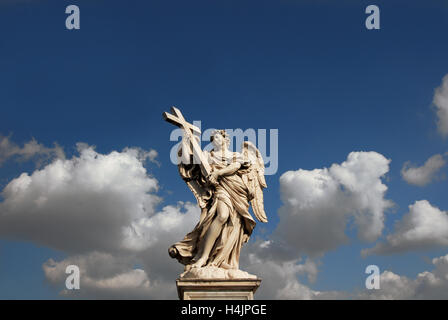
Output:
163 107 212 177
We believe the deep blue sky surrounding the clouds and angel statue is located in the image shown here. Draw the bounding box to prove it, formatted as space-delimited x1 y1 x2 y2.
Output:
0 0 448 299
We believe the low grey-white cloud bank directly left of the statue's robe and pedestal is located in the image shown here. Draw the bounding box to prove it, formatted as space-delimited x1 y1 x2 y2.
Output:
43 203 199 299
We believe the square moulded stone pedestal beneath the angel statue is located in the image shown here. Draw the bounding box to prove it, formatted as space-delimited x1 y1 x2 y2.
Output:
176 278 261 300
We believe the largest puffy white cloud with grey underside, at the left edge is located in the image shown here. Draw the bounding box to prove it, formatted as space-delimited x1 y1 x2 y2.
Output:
0 144 160 252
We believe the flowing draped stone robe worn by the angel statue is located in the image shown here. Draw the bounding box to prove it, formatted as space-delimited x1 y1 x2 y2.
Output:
173 151 256 269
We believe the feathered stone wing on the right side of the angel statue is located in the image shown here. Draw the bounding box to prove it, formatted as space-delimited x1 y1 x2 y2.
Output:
242 141 268 222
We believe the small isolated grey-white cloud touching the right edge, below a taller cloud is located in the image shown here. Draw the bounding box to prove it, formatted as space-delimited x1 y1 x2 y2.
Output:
401 154 446 187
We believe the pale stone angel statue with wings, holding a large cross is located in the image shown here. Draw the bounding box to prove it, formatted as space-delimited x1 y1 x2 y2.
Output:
164 107 268 278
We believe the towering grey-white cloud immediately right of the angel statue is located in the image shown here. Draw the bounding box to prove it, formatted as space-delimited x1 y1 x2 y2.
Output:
241 152 392 299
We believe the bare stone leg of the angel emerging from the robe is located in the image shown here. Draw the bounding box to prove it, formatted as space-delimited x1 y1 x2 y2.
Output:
193 200 229 268
